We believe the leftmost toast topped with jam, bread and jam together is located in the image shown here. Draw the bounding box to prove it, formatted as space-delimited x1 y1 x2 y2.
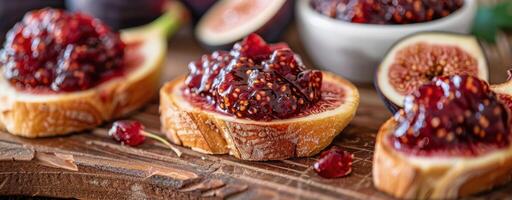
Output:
0 8 180 137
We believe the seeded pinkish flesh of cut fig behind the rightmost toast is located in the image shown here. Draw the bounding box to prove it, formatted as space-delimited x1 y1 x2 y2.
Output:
389 42 478 95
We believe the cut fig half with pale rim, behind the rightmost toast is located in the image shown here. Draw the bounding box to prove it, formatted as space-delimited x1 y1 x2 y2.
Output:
375 32 489 113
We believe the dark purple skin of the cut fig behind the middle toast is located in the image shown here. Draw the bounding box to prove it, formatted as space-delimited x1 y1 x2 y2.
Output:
198 0 295 52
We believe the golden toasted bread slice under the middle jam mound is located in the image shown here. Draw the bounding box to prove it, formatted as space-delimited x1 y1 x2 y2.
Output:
160 72 359 160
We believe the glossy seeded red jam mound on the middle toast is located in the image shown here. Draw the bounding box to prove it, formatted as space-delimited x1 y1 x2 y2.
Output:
185 34 322 121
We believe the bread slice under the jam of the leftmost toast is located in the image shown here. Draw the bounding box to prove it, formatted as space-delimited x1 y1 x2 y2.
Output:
0 35 166 138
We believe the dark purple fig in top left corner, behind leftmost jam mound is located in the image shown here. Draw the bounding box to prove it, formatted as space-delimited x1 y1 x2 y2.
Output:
0 0 65 43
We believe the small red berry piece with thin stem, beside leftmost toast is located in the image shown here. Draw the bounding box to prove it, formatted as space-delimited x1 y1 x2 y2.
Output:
108 120 146 146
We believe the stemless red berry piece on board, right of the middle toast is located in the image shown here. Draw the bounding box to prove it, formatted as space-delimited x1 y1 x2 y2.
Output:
313 146 354 178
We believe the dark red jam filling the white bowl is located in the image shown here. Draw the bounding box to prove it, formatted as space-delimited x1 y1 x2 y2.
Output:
311 0 464 24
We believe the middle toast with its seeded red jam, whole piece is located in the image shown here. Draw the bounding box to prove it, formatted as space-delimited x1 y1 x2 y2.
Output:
160 34 359 160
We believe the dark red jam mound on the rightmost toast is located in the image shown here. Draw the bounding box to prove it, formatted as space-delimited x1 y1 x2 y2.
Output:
390 75 511 156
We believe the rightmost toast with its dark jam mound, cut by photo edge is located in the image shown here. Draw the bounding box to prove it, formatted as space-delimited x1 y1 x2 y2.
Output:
373 75 512 199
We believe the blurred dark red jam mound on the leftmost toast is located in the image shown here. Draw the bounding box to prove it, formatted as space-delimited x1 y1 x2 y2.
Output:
0 8 125 92
